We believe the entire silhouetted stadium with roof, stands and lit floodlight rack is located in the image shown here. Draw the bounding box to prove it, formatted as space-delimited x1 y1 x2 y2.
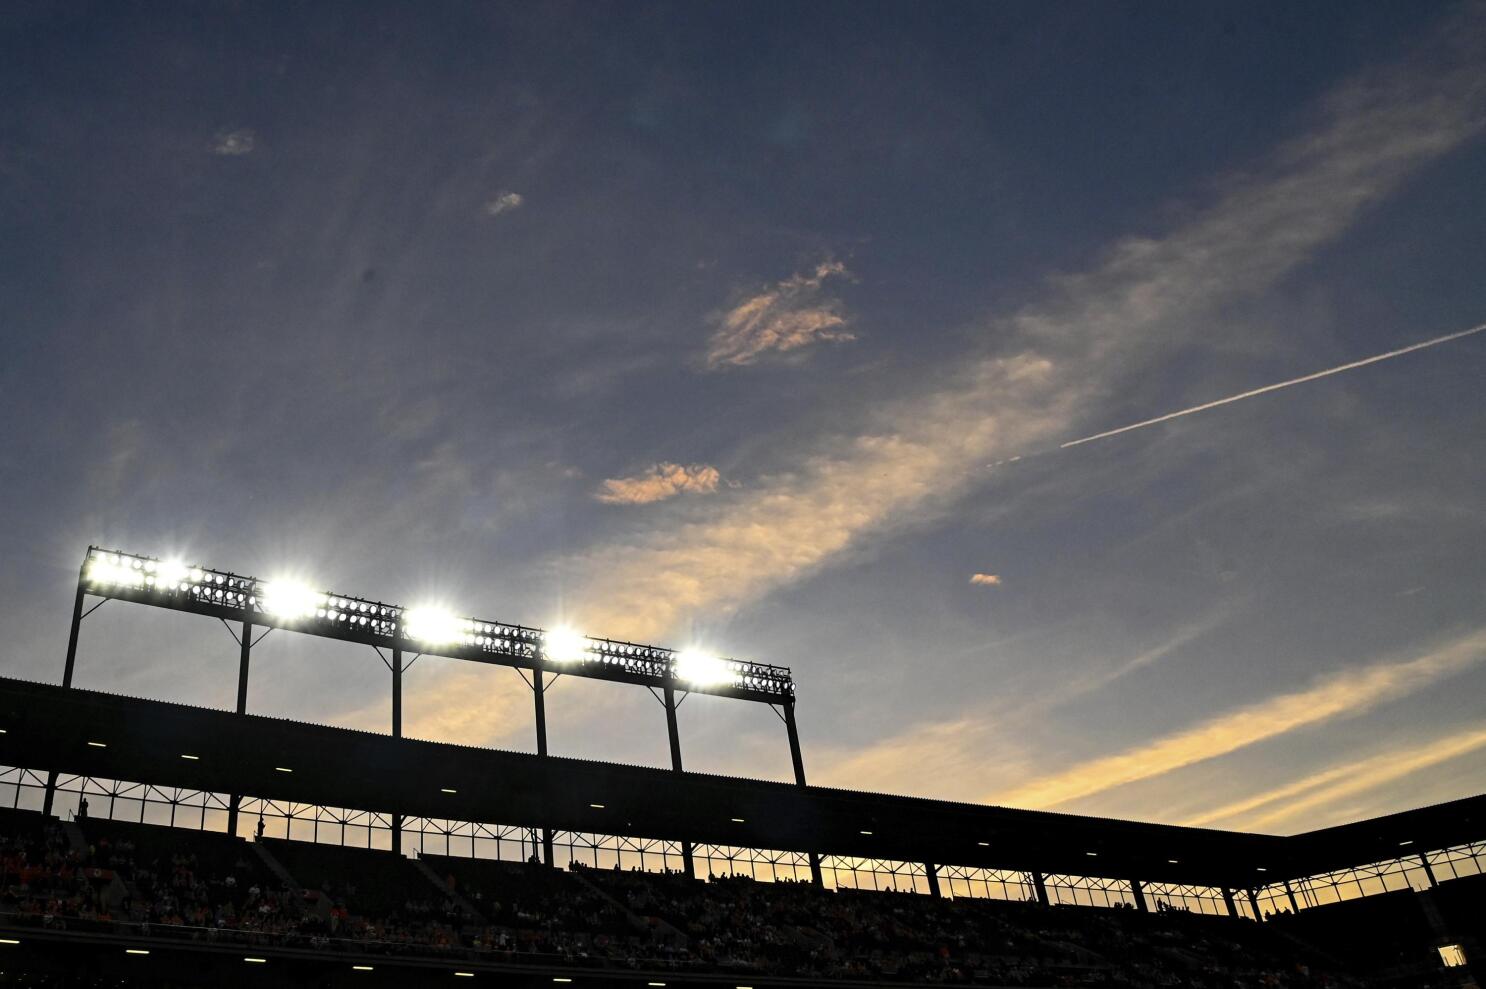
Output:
0 548 1486 988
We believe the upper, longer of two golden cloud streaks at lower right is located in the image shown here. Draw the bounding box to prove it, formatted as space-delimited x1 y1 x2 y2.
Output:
997 630 1486 808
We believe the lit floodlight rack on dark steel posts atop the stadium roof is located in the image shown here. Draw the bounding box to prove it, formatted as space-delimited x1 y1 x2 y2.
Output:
48 546 805 861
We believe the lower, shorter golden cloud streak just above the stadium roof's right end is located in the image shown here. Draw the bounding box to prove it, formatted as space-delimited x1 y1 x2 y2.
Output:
1181 715 1486 830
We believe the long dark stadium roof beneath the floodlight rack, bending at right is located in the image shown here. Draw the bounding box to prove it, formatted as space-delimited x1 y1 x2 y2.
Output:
0 677 1468 890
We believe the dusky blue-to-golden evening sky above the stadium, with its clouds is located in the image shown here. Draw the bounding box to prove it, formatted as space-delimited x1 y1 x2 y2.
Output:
0 0 1486 833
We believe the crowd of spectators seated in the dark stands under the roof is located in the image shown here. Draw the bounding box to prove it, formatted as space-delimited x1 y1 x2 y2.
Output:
0 811 1420 989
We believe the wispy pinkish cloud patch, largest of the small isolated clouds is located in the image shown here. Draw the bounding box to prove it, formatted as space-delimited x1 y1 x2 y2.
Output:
707 261 856 370
